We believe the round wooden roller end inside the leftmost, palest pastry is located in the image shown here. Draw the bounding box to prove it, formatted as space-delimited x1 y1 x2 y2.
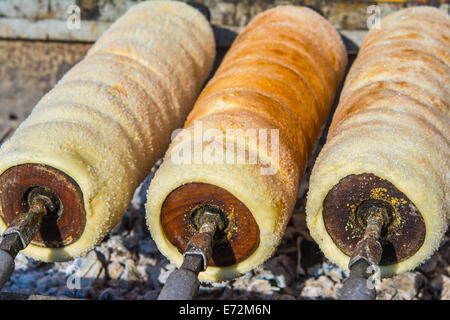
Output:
0 163 86 248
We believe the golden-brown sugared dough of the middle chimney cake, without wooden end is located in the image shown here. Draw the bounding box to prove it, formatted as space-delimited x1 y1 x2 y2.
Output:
147 6 347 281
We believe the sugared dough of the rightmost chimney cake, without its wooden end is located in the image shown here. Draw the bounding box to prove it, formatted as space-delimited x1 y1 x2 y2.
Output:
306 7 450 275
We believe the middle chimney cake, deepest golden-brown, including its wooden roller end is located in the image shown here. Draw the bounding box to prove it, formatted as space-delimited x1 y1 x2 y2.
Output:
146 6 347 282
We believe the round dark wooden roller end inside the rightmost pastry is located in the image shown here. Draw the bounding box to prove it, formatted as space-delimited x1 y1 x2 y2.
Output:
323 173 426 265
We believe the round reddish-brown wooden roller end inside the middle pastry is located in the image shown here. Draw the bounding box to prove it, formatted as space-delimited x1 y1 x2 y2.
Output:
161 182 259 267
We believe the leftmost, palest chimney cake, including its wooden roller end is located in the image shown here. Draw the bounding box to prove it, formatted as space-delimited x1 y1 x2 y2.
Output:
0 1 215 261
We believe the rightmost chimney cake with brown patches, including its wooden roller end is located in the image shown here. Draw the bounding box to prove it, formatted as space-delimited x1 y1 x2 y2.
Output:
306 7 450 276
